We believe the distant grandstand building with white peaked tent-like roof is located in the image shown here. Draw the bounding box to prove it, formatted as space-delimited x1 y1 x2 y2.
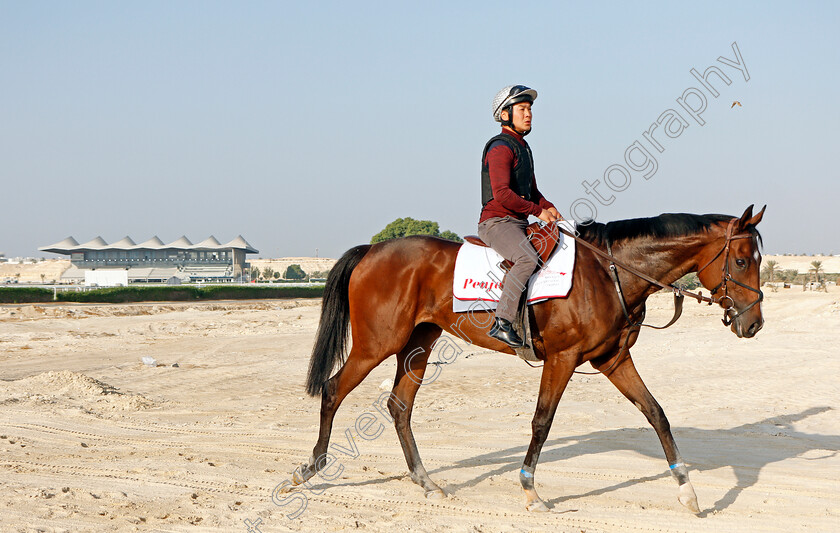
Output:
38 235 259 283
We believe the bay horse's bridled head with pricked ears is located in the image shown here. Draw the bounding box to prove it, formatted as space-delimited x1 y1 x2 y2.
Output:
697 206 767 338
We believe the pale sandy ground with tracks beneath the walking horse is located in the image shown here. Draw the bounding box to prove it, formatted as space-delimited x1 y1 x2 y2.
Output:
0 287 840 533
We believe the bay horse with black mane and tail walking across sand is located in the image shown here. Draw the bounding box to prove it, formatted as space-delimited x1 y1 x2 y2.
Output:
282 206 766 513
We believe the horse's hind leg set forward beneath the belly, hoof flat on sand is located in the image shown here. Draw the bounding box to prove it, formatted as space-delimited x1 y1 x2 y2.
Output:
388 323 446 498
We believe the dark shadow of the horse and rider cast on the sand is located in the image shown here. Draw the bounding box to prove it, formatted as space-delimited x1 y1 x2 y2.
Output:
319 406 840 516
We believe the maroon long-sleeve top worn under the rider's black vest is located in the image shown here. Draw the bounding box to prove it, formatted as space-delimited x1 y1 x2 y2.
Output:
478 128 554 222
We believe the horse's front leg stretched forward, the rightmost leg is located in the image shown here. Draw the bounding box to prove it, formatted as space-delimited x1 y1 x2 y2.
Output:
593 353 700 513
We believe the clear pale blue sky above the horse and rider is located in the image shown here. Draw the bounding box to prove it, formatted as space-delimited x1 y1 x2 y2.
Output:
0 0 840 257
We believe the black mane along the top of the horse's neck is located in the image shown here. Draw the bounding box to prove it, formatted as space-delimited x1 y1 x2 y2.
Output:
577 213 761 245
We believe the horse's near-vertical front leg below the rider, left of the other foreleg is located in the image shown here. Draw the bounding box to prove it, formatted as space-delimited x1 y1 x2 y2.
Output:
519 354 575 511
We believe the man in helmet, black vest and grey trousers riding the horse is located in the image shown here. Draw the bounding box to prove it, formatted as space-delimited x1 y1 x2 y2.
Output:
478 85 562 348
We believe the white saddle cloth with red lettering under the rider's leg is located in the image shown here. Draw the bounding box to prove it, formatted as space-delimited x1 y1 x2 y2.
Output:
452 220 575 313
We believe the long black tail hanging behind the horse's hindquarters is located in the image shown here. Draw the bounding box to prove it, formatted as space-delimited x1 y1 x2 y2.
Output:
306 244 370 396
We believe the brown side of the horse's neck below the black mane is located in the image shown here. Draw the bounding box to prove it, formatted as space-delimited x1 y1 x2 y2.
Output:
613 233 715 306
